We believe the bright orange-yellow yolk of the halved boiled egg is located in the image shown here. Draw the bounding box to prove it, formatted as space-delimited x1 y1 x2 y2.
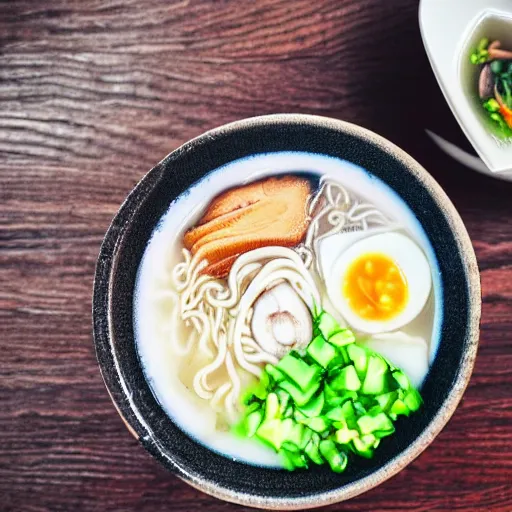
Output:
343 254 409 320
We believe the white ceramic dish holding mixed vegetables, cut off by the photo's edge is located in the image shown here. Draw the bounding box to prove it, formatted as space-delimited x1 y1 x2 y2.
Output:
419 0 512 180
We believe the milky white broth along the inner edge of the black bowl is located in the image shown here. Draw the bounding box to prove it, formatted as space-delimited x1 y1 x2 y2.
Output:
134 152 442 466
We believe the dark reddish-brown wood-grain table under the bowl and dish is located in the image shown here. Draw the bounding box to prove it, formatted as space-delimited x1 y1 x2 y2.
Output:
0 0 512 512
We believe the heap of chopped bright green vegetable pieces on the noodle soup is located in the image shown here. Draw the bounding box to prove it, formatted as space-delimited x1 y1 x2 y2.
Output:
236 312 422 472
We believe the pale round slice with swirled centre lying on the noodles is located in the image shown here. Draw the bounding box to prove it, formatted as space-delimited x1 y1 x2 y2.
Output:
251 282 313 358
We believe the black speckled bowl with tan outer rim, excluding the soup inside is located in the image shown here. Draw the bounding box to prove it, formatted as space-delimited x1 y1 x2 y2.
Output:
93 114 481 510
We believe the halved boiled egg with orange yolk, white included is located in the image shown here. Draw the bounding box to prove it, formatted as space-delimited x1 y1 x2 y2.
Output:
319 232 432 334
